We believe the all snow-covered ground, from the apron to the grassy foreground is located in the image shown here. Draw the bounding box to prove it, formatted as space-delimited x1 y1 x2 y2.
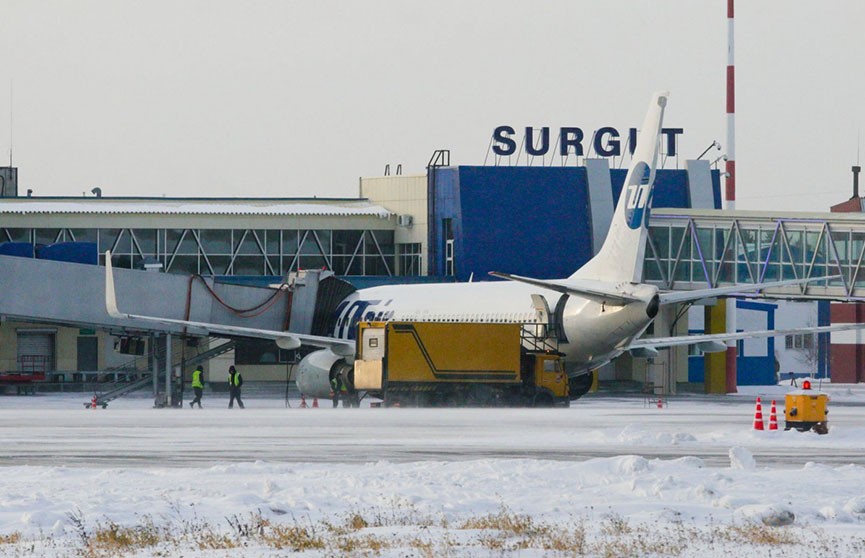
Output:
0 385 865 556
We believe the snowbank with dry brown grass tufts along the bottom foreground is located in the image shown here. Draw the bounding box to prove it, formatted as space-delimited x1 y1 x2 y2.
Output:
0 456 865 557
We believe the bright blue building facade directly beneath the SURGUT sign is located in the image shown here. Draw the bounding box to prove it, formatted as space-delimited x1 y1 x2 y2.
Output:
427 165 721 281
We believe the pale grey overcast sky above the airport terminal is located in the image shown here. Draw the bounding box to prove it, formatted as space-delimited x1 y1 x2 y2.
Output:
0 0 865 211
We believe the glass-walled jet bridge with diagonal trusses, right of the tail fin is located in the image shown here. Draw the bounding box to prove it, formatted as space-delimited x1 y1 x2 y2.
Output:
643 209 865 301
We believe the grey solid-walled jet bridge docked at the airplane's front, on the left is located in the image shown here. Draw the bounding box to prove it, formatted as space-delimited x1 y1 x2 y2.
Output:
0 256 352 336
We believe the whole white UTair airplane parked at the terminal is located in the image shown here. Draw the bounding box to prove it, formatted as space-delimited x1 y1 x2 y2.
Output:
105 92 852 398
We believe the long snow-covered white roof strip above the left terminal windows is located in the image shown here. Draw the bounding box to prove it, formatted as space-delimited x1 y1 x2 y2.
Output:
0 198 394 219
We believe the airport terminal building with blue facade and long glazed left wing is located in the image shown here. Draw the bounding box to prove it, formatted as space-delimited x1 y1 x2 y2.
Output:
0 151 856 391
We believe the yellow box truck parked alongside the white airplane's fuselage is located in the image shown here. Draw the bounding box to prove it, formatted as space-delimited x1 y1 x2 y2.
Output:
352 322 569 406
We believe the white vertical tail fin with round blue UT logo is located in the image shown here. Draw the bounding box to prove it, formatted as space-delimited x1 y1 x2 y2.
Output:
571 91 670 283
